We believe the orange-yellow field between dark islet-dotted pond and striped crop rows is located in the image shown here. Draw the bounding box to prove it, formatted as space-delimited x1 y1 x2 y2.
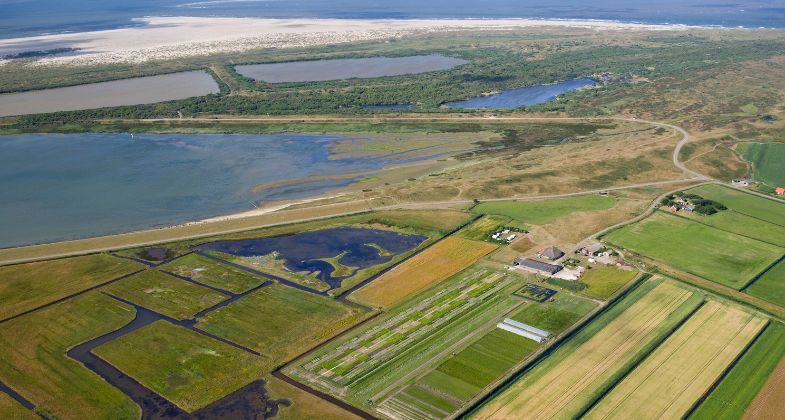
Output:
352 236 496 308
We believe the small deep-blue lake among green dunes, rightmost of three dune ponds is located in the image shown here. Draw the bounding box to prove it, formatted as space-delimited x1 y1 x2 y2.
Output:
447 77 597 108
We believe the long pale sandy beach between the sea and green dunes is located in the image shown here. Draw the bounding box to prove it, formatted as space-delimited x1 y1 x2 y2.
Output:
0 17 686 65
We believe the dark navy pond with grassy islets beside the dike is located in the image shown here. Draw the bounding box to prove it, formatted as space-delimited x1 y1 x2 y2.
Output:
197 227 428 288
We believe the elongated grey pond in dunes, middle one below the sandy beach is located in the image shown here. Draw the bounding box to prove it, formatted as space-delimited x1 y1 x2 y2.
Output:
235 54 469 83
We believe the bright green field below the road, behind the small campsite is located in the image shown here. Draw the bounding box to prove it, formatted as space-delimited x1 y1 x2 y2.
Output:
472 194 616 225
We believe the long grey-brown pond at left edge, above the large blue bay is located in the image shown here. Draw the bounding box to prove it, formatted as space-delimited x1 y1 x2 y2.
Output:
0 71 220 117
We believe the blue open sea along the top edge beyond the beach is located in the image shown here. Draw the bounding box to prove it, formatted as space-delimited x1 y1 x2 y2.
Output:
0 0 785 38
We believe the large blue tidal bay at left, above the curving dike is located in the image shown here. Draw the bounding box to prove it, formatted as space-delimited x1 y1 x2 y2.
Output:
0 134 440 247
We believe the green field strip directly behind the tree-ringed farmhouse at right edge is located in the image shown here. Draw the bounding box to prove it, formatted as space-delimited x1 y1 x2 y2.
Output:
687 184 785 226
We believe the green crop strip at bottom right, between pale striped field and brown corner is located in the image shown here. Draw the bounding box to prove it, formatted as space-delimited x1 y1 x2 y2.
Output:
690 322 785 420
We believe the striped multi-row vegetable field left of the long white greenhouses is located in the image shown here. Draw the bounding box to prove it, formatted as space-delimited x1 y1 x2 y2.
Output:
286 270 525 405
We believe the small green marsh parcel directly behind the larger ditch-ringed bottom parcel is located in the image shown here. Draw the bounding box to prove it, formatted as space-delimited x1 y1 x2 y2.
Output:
104 270 229 319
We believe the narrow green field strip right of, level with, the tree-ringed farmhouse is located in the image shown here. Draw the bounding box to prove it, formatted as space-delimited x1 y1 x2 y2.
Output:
690 210 785 247
